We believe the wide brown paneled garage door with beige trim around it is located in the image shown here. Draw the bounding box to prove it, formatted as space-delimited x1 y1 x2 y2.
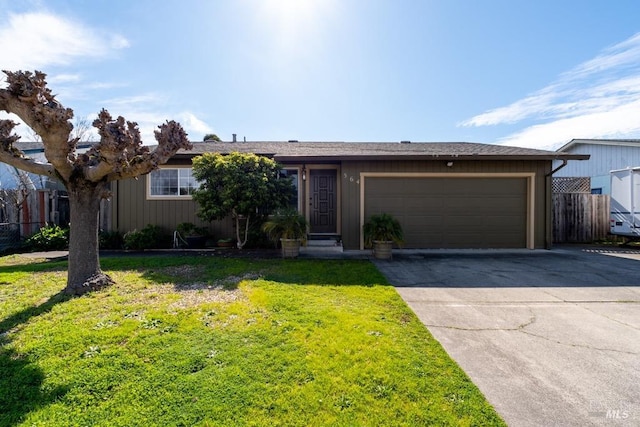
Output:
365 177 527 248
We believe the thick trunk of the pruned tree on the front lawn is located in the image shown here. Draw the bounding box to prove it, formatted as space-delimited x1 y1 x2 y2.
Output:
65 182 114 295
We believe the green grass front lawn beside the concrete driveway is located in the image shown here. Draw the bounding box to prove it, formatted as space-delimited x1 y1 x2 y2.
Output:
0 256 504 426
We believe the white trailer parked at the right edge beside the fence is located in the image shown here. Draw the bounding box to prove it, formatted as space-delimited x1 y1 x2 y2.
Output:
610 167 640 237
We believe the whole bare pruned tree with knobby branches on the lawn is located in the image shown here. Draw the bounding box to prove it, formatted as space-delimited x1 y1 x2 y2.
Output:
0 71 191 295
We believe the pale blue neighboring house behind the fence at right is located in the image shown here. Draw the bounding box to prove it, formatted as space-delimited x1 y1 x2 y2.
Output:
553 139 640 194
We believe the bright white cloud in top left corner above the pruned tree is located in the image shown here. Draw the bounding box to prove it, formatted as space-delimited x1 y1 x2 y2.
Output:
0 12 129 70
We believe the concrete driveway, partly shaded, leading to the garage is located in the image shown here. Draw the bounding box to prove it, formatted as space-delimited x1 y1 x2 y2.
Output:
375 248 640 426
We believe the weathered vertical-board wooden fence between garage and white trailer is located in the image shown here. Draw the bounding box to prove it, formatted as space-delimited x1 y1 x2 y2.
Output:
553 193 610 243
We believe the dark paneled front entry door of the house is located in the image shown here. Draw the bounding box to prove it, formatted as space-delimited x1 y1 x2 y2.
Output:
309 169 338 233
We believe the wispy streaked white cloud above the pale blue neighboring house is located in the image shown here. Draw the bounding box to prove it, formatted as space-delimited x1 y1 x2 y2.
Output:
459 33 640 148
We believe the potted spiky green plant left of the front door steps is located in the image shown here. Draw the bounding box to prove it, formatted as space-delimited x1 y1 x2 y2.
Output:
262 209 307 258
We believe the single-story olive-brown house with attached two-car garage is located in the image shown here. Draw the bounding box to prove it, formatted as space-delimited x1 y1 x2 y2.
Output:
112 141 588 249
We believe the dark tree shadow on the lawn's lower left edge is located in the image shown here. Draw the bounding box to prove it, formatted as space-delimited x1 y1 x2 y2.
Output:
0 292 70 426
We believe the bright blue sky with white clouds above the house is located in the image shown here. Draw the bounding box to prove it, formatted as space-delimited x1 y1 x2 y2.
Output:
0 0 640 149
